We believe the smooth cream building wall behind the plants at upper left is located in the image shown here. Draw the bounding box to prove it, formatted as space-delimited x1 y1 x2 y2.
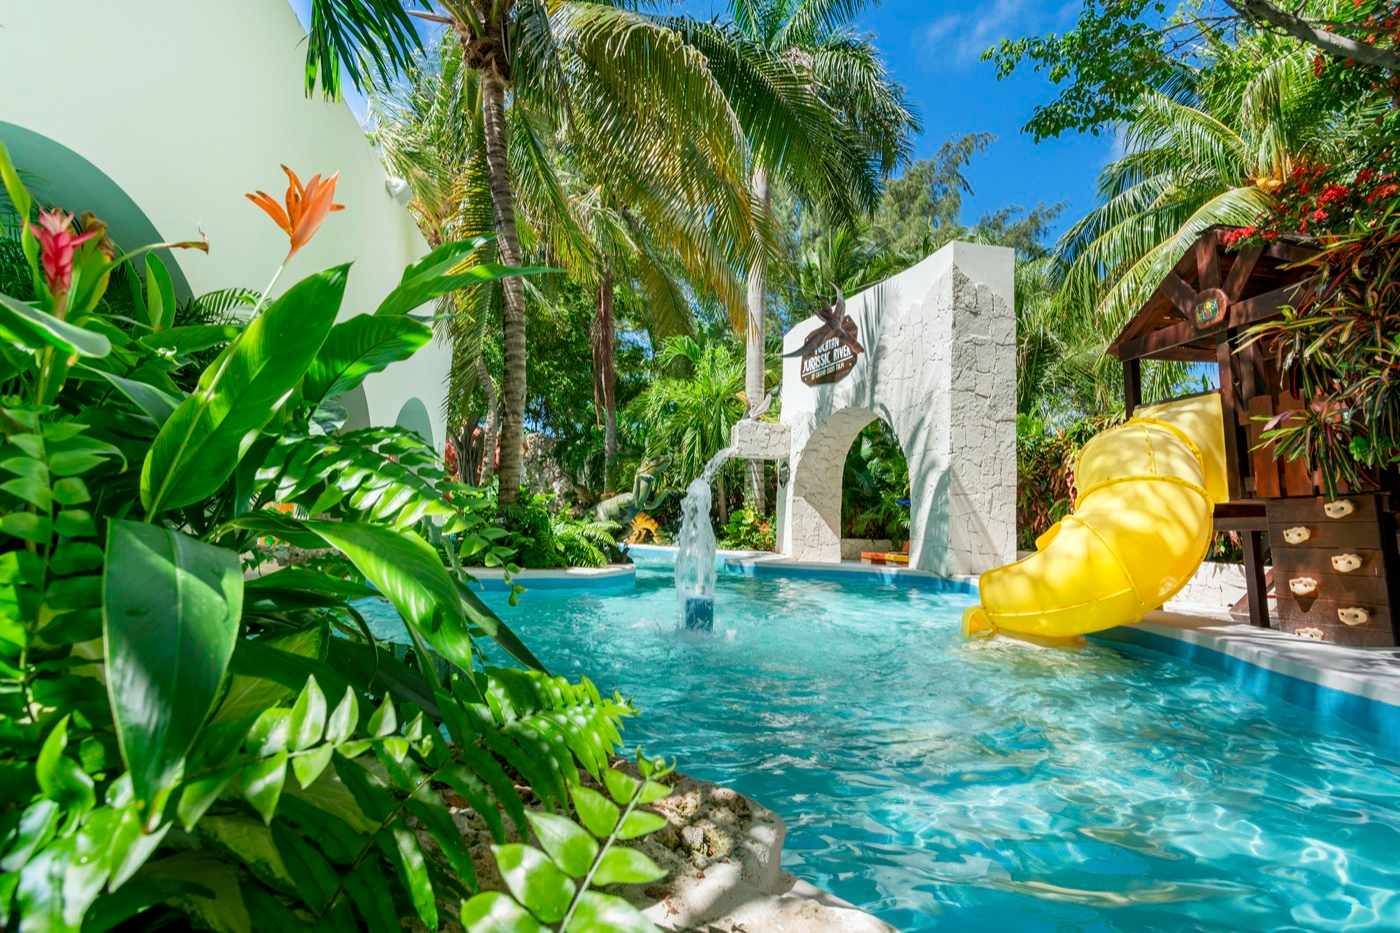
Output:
0 0 449 445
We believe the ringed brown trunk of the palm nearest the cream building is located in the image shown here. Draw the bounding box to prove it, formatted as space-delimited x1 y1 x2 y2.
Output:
482 67 526 504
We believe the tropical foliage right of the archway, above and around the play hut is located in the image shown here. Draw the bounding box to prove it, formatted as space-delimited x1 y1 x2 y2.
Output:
990 0 1400 546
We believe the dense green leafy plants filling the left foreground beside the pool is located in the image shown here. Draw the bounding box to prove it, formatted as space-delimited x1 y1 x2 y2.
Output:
0 147 666 932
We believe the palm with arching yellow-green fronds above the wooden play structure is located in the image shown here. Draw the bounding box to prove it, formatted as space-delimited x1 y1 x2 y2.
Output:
1057 23 1341 329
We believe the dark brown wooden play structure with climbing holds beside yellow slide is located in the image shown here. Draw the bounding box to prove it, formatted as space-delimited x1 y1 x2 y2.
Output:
1109 228 1400 646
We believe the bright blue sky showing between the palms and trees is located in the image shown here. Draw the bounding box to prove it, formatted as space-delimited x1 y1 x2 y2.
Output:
290 0 1113 239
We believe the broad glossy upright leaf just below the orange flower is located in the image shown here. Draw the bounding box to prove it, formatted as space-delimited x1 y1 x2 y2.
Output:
141 266 347 516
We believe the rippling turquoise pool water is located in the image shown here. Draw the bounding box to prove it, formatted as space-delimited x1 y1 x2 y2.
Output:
364 554 1400 930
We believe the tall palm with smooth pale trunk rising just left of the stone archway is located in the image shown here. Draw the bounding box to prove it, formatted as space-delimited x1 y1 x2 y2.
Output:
671 0 918 513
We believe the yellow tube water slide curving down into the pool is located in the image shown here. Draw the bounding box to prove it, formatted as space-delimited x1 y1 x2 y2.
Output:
963 392 1229 639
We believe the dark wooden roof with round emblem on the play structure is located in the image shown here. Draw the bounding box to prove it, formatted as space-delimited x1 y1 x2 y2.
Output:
1107 227 1316 361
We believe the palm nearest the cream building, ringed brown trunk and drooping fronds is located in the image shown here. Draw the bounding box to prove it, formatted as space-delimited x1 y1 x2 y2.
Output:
307 0 753 504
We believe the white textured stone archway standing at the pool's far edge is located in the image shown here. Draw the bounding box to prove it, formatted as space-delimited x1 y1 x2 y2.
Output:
778 242 1016 574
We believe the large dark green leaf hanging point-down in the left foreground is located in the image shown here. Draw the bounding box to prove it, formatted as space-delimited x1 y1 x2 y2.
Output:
102 520 244 810
